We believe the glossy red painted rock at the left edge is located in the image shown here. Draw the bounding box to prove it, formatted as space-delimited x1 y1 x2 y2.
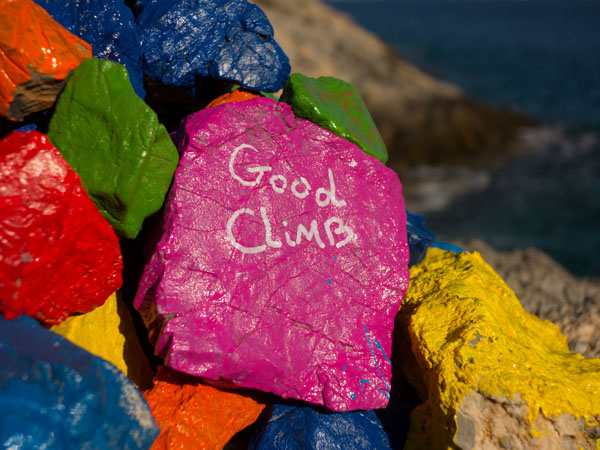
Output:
0 131 122 324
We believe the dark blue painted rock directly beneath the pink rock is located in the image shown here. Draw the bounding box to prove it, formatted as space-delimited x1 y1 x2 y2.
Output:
250 404 390 450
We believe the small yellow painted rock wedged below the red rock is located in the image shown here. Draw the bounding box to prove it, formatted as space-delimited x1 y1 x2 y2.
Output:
51 294 154 389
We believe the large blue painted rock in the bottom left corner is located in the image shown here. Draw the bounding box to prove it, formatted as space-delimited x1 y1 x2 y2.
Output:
0 316 158 450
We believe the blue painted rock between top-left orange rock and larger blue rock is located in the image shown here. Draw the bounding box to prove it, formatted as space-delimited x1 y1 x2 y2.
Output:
35 0 146 99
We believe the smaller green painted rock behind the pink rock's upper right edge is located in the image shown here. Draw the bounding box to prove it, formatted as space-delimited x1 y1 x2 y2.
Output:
279 73 388 164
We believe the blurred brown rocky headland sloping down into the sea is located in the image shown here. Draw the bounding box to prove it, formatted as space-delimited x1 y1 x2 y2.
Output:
253 0 531 169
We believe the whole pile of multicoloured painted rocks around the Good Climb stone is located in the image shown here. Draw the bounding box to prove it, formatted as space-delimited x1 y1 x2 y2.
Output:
0 0 600 449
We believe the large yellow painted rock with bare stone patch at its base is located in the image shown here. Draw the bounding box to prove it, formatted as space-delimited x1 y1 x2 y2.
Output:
394 248 600 449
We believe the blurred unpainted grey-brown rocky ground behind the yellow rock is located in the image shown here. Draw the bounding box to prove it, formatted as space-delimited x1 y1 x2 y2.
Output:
460 239 600 358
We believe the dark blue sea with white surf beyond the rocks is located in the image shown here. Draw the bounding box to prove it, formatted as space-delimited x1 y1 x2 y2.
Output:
329 0 600 276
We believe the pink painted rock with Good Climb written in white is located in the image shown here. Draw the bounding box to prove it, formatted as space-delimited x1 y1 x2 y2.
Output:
135 98 409 411
